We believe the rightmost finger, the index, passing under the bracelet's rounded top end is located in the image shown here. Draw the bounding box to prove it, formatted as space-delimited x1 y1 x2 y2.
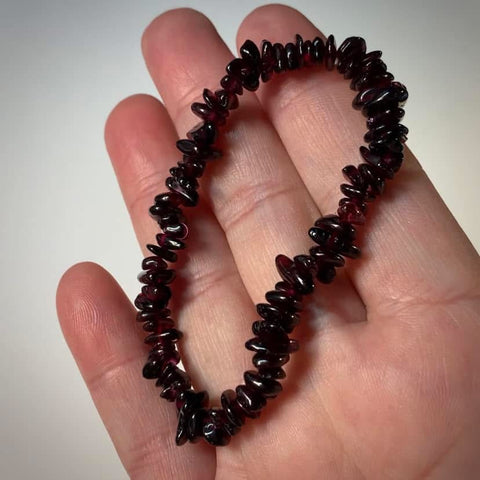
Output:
237 5 479 315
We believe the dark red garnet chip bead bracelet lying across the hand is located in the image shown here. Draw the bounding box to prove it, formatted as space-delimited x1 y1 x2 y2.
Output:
135 35 408 446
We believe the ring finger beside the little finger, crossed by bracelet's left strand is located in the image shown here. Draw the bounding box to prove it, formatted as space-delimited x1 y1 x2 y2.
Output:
105 95 255 396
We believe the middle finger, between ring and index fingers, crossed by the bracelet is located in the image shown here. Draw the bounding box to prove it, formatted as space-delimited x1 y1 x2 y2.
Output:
142 9 364 318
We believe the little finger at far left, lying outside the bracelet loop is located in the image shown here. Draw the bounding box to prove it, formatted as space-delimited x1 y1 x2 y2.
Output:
57 263 215 479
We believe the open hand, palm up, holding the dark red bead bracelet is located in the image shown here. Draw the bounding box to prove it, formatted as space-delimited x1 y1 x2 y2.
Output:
57 5 480 480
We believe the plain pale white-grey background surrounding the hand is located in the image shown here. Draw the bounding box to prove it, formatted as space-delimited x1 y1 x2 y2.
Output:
0 0 480 480
